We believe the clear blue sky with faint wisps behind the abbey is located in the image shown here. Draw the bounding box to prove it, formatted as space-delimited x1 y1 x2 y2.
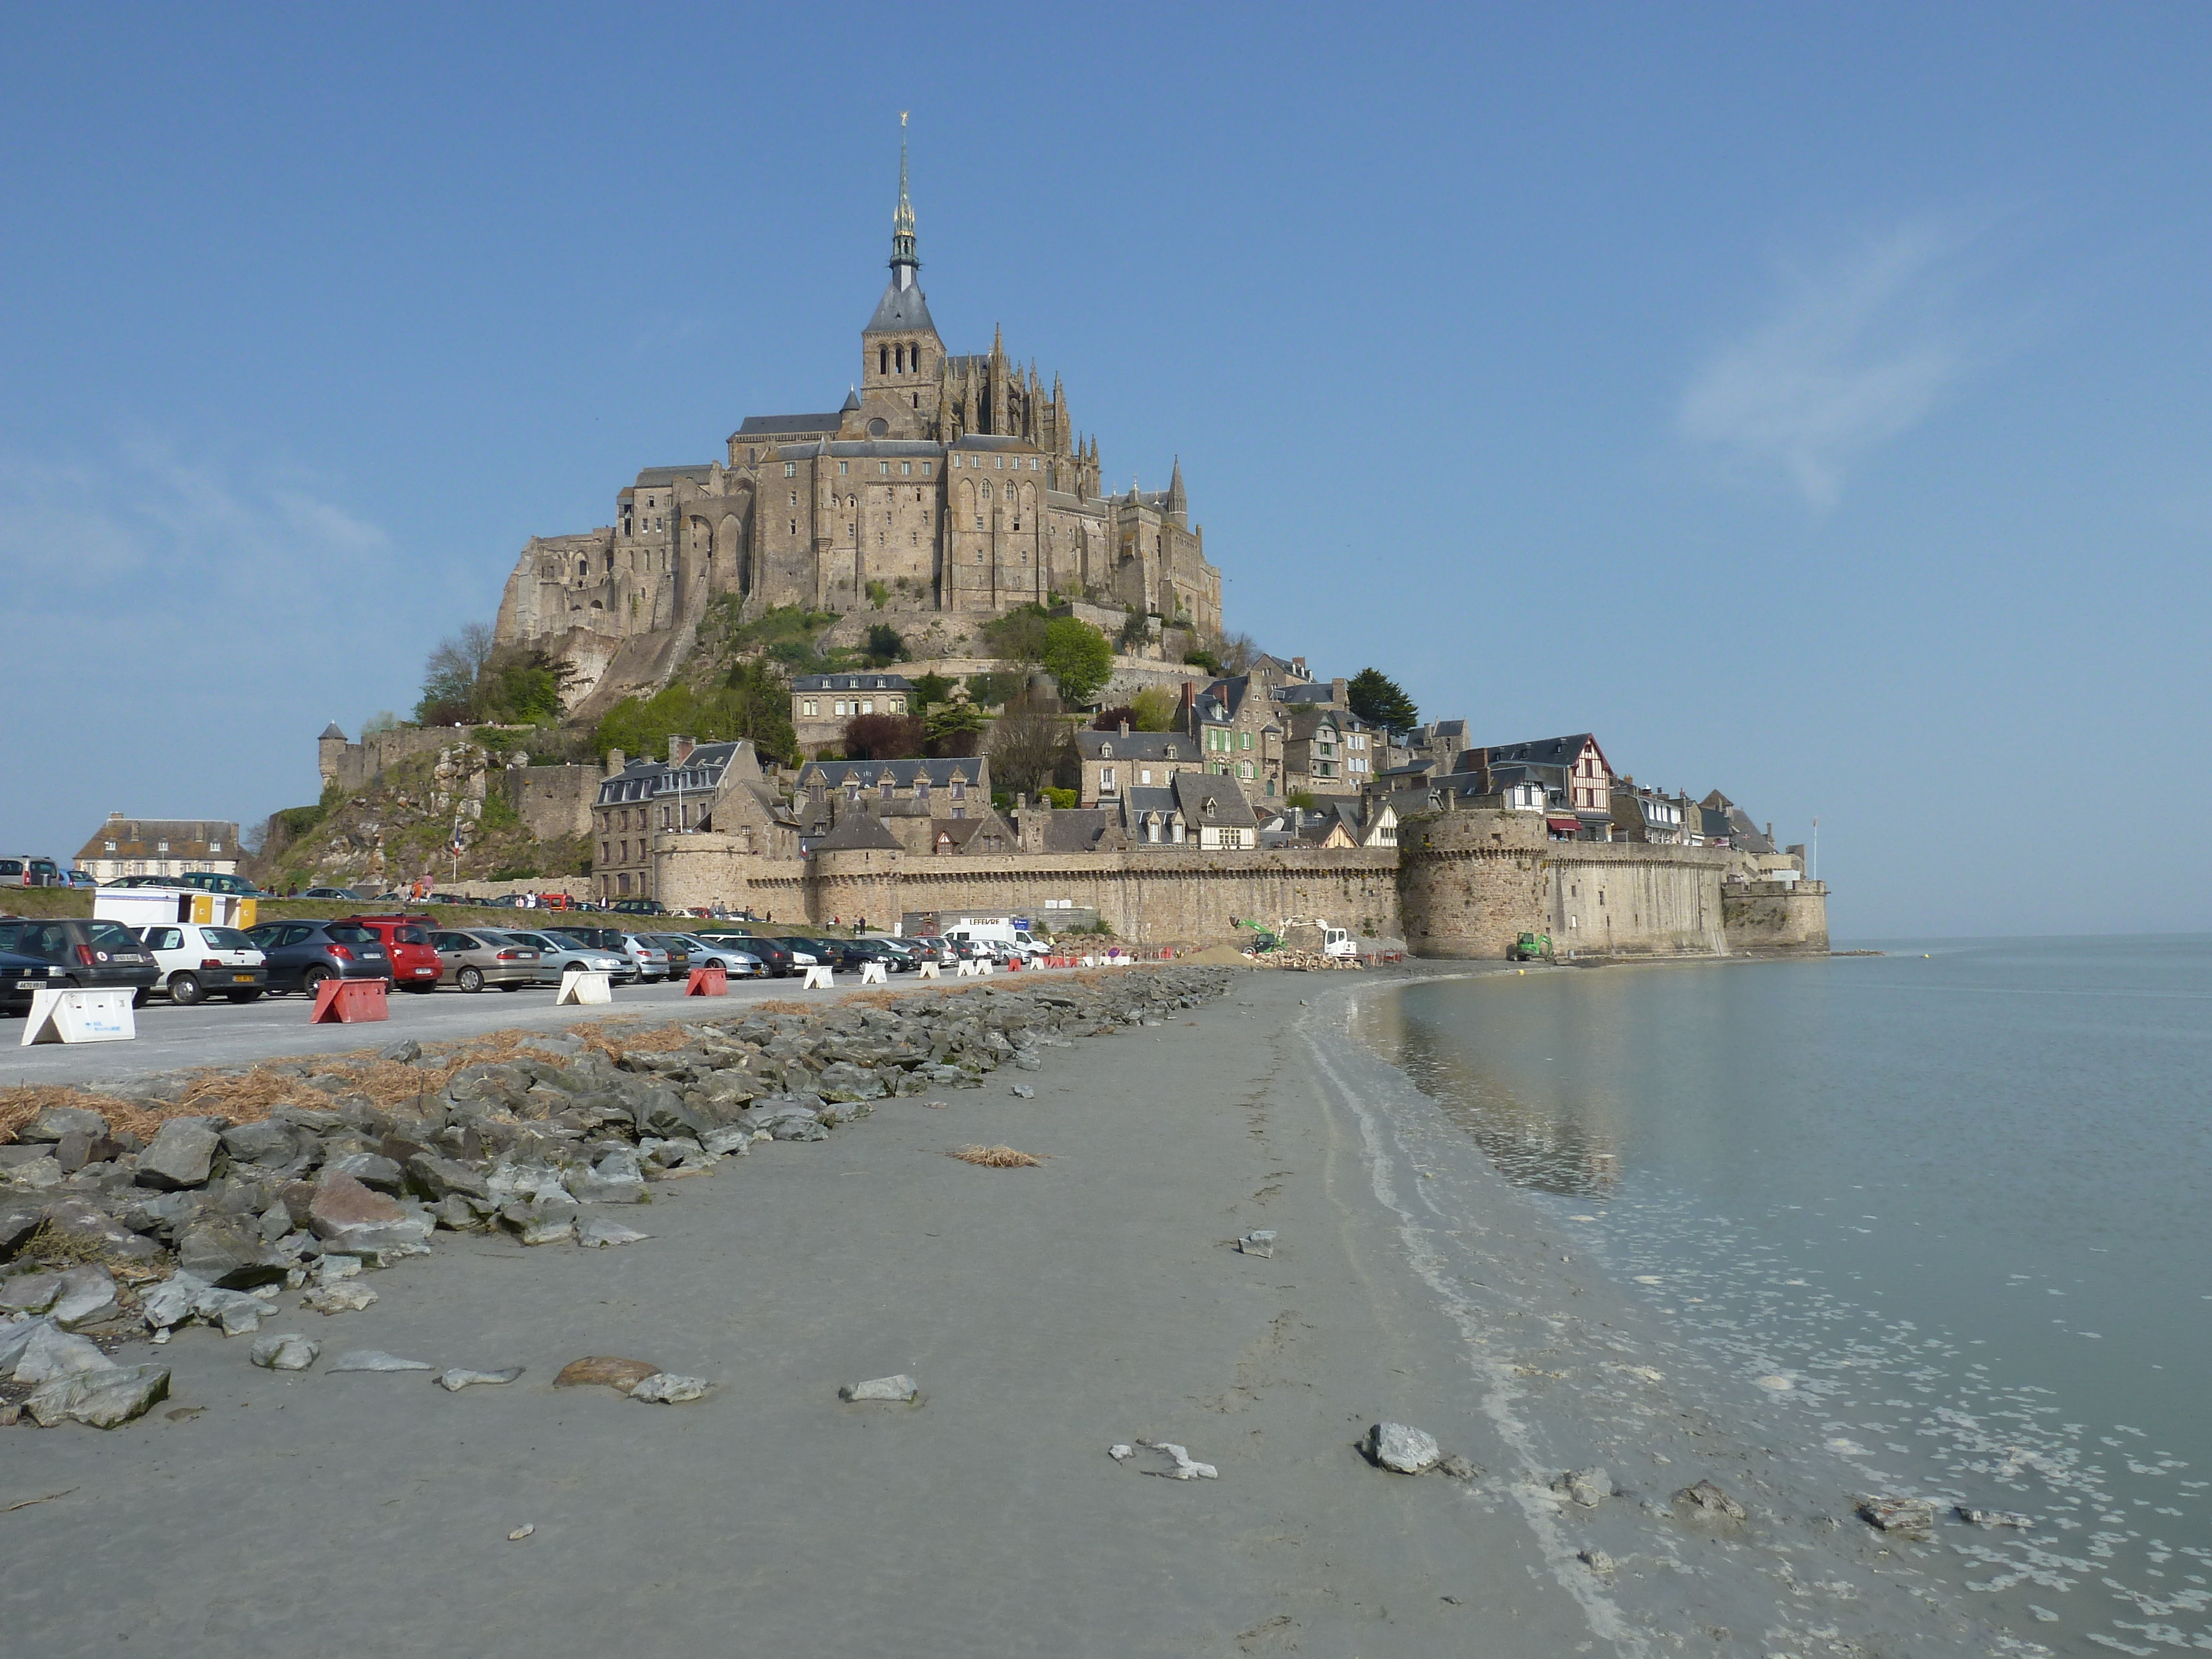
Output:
0 4 2212 936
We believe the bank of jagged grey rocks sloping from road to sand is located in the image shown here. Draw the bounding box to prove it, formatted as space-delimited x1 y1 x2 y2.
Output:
0 967 1261 1427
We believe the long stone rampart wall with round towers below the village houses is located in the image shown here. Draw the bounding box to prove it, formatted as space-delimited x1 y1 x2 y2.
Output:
655 812 1827 960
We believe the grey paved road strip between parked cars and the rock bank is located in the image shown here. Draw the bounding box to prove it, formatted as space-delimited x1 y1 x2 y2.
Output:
0 969 1062 1088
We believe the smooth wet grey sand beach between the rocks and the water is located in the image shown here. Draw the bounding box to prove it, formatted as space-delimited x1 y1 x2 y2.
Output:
0 973 1995 1659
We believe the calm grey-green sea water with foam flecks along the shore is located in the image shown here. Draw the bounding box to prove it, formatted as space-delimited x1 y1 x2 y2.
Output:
1363 938 2212 1655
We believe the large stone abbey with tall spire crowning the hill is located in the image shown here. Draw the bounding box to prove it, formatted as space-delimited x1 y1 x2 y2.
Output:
498 127 1221 690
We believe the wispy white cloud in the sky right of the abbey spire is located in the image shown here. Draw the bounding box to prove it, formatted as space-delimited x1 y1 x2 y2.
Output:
1674 223 1978 507
